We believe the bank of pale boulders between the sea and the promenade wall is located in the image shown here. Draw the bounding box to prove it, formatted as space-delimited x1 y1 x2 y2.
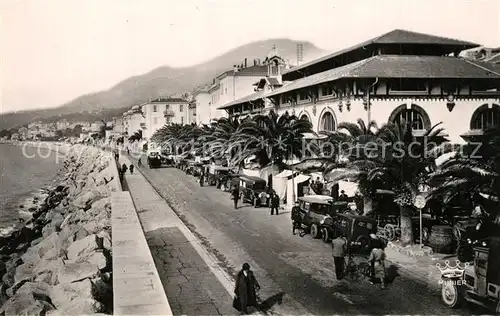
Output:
0 145 120 315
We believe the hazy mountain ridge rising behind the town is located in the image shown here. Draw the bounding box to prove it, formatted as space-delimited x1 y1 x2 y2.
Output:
0 38 325 130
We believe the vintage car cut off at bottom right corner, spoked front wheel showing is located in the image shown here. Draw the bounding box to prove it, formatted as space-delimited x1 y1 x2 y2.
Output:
439 237 500 314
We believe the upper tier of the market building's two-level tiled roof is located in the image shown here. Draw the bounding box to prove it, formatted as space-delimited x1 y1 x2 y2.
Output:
284 29 480 74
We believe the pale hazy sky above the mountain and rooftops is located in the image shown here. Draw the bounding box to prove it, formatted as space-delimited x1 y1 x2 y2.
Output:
0 0 500 112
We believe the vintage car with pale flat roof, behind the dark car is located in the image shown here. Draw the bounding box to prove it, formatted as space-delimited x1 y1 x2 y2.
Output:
298 195 334 238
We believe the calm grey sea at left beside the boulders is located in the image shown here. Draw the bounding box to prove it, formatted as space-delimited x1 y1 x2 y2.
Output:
0 143 63 236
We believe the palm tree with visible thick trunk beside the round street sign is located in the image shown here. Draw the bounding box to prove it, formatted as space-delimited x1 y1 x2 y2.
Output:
328 122 447 244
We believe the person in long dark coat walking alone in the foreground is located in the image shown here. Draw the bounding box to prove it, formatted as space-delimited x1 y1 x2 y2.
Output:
233 263 260 314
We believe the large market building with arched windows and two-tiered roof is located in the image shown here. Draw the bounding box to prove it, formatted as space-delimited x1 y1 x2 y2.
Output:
223 30 500 143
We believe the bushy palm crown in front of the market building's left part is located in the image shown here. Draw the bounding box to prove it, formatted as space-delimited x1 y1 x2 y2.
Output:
231 111 312 170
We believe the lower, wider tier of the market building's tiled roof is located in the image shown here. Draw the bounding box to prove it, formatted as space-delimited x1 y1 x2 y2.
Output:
266 55 500 97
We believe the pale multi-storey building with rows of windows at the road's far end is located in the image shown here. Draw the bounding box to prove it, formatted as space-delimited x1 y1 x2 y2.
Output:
142 98 189 140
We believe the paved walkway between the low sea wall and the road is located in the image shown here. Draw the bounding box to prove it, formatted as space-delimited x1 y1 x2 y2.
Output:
120 157 236 315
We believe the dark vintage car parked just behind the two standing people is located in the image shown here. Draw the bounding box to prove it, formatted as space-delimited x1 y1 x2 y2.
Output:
321 214 377 252
